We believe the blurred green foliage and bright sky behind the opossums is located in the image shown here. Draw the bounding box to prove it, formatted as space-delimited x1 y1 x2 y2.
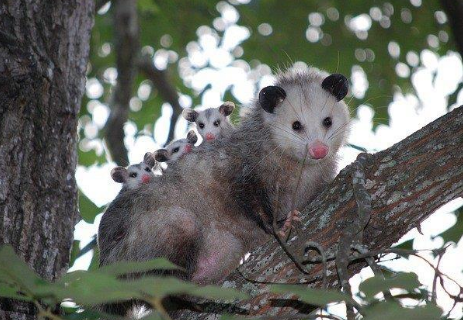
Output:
71 0 463 317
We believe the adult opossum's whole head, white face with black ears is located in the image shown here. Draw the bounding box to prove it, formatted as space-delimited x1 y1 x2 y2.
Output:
259 68 350 164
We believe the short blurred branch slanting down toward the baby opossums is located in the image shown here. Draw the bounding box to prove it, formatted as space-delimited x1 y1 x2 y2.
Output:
137 55 182 142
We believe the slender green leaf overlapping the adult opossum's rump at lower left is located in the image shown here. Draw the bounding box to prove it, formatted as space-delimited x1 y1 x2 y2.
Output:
98 258 184 276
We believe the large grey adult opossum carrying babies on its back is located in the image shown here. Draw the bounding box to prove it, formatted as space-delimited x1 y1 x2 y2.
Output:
99 68 349 308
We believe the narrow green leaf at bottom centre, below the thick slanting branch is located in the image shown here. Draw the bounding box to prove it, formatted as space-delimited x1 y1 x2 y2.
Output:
270 285 353 307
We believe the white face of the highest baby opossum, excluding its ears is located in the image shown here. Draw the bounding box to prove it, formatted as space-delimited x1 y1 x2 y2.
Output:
195 108 230 141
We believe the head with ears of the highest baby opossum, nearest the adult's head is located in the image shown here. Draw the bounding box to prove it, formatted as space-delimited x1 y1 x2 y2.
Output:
182 101 235 141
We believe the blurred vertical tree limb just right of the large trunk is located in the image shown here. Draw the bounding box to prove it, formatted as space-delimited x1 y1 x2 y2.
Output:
105 0 139 166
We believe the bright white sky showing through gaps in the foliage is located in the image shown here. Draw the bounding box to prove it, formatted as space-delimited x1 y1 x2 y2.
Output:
71 6 463 317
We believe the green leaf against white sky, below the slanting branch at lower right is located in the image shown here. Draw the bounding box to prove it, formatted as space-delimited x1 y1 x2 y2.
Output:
359 273 420 299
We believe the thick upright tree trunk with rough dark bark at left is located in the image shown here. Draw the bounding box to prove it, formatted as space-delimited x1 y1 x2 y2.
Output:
0 0 94 319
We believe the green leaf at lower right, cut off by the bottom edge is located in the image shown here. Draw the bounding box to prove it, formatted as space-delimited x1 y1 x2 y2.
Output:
363 302 442 320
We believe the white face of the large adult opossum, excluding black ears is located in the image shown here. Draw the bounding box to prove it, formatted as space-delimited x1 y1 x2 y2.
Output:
264 81 350 164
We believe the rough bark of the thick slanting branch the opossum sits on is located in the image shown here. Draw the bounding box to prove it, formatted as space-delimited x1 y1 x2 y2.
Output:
181 106 463 319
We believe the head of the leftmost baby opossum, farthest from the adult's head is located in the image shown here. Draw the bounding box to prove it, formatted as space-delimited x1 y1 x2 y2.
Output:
111 152 156 189
